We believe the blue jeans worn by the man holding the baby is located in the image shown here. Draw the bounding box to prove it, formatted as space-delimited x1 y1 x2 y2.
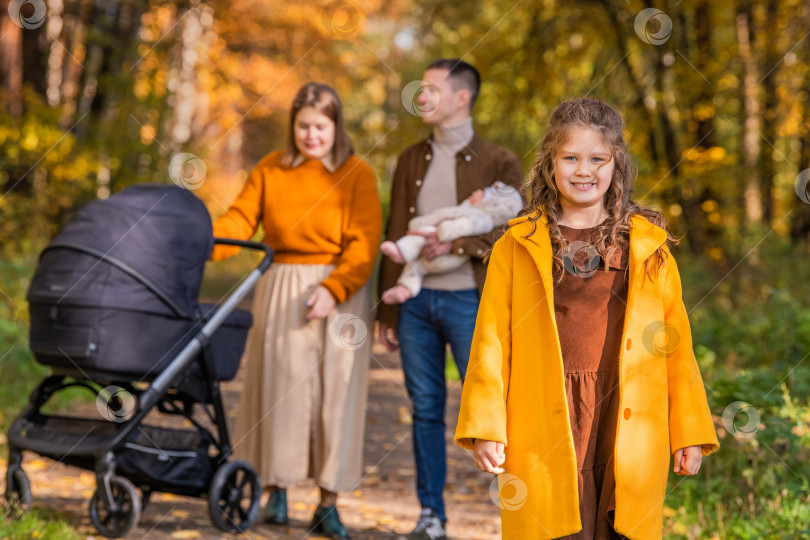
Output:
397 289 478 520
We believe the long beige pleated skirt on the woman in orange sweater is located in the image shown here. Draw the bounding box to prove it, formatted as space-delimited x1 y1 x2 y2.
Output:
233 264 373 493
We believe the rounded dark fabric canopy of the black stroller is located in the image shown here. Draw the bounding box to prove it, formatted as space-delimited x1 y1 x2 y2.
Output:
29 184 214 318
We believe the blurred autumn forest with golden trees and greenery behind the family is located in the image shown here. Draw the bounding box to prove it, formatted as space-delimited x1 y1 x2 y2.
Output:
0 0 810 538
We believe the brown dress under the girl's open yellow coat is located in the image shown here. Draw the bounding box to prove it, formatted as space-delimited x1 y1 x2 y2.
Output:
554 226 627 540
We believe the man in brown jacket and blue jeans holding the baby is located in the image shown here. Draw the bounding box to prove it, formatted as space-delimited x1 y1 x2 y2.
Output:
377 59 523 540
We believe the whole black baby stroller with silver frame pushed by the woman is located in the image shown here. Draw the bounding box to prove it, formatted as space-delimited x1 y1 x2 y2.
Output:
6 184 273 537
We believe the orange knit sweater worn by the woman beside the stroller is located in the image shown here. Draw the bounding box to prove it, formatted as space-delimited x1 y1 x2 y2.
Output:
211 152 382 303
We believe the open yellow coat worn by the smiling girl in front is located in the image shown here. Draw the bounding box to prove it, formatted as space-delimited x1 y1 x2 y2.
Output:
455 216 718 540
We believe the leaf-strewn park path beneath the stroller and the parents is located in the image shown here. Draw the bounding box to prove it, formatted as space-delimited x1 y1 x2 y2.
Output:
0 343 500 540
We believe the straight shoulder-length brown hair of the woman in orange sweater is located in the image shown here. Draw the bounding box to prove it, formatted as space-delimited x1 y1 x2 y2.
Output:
281 83 354 169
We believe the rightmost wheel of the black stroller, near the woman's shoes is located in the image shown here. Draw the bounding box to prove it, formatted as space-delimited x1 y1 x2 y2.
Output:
208 461 262 532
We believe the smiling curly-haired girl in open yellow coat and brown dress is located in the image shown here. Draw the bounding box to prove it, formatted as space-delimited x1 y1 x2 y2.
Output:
455 98 718 540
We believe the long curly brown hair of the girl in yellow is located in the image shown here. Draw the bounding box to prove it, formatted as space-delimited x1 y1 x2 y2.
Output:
523 97 678 279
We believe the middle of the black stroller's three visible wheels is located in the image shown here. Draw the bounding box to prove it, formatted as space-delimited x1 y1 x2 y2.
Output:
90 476 141 538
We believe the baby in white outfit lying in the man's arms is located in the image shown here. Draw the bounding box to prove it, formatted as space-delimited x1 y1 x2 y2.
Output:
380 181 523 304
